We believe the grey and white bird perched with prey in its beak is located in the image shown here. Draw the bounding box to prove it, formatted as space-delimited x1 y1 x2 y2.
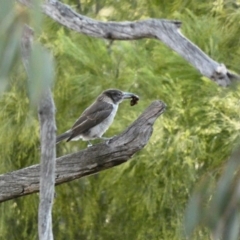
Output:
56 89 139 146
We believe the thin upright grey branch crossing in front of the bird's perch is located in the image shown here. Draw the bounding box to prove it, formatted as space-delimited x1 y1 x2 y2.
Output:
22 26 56 240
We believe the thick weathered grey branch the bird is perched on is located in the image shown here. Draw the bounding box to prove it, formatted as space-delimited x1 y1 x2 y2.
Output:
0 101 165 202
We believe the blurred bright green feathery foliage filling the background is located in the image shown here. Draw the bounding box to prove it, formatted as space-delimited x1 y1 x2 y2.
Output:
0 0 240 240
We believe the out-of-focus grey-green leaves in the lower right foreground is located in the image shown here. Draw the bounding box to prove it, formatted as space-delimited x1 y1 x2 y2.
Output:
185 150 240 240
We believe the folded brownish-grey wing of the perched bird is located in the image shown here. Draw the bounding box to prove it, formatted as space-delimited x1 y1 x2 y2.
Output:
67 102 113 141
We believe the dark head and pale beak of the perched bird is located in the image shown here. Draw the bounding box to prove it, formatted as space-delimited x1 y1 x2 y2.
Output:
101 89 138 104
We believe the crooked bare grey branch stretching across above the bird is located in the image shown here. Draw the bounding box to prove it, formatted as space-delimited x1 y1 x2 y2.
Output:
17 0 239 86
